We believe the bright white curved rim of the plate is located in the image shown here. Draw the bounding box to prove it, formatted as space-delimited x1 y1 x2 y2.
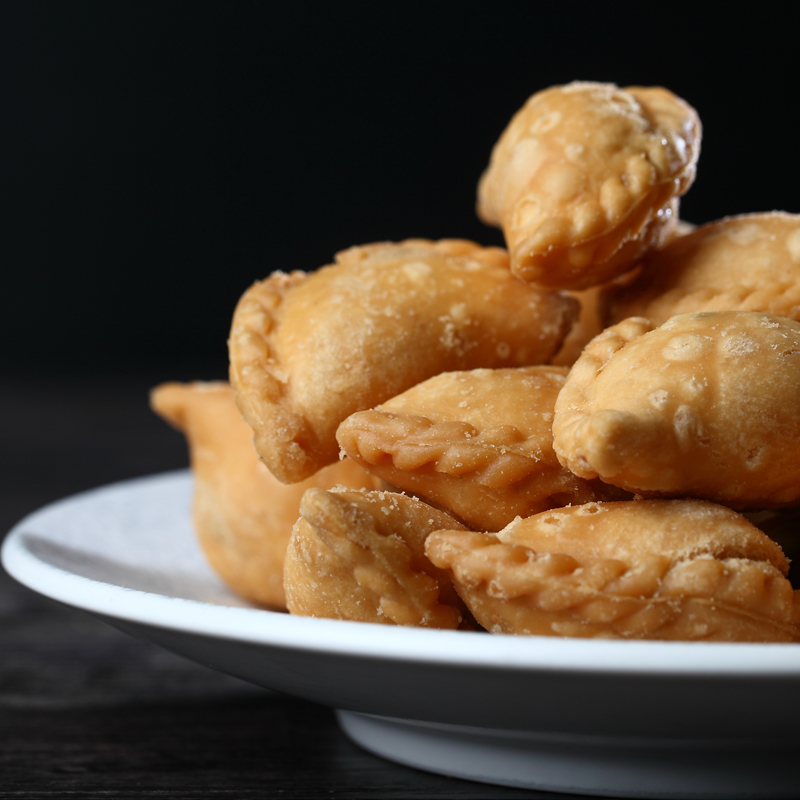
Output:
6 469 800 680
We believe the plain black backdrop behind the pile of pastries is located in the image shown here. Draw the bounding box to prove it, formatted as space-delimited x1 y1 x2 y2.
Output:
0 0 800 378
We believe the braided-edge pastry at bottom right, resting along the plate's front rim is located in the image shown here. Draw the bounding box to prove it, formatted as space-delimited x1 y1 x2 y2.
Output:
426 500 800 642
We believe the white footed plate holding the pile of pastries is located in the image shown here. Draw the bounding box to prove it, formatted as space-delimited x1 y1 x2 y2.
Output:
2 472 800 798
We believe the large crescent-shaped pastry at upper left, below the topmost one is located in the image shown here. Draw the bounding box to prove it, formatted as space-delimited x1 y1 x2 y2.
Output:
229 240 577 483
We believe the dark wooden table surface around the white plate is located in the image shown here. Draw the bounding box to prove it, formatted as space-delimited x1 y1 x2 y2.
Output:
0 374 563 800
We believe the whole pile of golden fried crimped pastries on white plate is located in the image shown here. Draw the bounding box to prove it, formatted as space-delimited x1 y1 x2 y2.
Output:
152 82 800 642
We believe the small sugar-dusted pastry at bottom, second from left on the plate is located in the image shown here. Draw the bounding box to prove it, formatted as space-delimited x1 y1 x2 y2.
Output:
284 489 474 629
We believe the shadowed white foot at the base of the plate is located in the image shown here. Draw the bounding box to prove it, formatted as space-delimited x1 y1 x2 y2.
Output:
336 711 800 800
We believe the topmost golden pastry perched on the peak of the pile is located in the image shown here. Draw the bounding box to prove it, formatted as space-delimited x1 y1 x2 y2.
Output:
477 82 701 289
